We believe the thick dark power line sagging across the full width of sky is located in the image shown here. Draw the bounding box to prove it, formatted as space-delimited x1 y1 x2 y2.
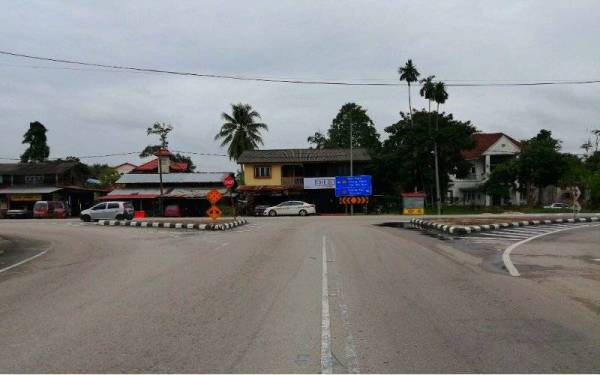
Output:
0 50 600 87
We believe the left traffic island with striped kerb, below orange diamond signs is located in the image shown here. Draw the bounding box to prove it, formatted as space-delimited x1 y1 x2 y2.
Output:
97 218 248 231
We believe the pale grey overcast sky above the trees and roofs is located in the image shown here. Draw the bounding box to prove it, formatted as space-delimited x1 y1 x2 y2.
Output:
0 0 600 171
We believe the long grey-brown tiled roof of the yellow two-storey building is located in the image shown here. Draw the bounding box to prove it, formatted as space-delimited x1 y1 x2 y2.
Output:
238 148 371 164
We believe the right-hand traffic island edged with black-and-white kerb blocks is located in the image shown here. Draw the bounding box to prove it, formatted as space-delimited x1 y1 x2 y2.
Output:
409 216 600 235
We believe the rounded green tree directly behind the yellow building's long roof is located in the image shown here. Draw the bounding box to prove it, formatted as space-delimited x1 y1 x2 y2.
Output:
325 103 381 152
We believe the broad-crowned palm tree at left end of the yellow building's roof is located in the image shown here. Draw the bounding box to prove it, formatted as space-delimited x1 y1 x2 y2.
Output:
215 103 269 161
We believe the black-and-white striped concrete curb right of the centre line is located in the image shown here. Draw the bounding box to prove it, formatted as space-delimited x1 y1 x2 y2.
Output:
410 216 600 235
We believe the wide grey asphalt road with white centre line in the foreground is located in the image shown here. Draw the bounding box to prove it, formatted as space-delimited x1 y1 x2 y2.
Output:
0 217 600 373
